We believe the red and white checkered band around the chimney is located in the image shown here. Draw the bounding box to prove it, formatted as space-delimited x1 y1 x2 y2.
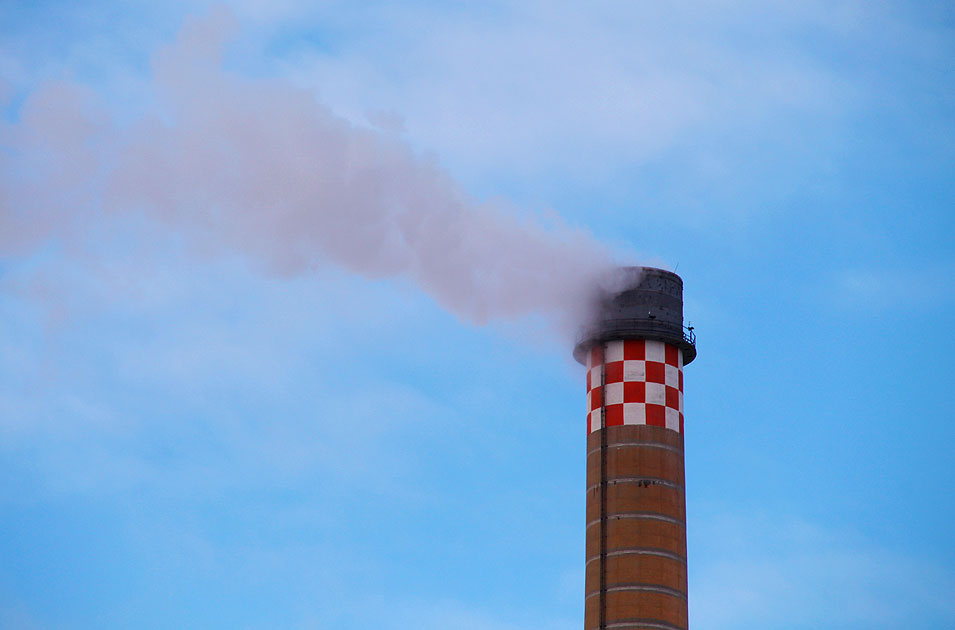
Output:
587 339 683 433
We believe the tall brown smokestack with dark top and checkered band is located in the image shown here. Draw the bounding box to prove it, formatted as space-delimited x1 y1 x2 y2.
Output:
574 267 696 630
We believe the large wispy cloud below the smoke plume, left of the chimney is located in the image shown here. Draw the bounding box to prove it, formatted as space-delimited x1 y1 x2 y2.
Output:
0 226 446 494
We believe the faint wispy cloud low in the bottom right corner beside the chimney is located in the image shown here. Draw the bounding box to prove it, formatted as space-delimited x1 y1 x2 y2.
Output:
690 514 955 630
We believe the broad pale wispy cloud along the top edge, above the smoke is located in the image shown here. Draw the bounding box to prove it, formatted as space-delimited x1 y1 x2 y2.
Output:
284 2 862 180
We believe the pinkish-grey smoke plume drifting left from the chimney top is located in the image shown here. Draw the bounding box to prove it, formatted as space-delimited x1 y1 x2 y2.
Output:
0 9 610 336
